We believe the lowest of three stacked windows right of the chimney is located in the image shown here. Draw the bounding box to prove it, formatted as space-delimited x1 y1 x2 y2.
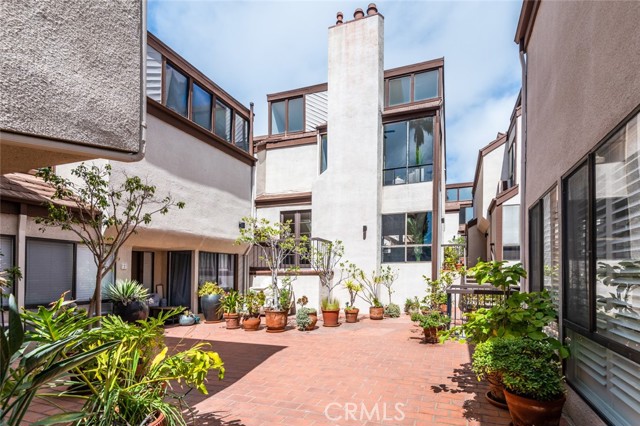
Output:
382 212 433 263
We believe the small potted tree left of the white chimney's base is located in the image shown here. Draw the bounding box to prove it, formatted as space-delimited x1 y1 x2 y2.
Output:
236 217 307 309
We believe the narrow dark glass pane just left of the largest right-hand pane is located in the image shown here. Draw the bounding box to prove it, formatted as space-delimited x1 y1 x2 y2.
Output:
565 164 589 328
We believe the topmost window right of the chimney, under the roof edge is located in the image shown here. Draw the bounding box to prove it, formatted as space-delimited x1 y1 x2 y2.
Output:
387 70 440 106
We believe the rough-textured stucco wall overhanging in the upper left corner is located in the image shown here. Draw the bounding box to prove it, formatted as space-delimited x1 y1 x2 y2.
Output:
0 0 146 171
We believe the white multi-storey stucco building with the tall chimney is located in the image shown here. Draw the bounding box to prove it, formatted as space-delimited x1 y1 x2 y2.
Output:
252 6 445 308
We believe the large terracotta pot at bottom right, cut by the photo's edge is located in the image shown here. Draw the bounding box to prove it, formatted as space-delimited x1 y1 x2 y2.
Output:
504 389 566 426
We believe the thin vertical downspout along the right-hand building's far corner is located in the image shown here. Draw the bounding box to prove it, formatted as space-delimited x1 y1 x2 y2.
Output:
519 39 529 291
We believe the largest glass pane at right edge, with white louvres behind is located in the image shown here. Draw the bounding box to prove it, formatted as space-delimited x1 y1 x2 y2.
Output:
595 112 640 351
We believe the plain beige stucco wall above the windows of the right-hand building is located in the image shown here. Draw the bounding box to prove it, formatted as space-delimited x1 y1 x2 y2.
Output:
525 1 640 208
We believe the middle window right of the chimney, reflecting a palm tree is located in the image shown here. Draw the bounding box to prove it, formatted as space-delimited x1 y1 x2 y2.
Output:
383 117 433 185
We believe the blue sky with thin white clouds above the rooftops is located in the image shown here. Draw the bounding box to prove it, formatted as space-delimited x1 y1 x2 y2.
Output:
147 0 522 183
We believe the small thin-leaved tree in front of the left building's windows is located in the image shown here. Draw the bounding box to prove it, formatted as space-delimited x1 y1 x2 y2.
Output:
36 163 184 316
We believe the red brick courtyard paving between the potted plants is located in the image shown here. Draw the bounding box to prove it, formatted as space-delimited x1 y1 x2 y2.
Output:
29 316 510 426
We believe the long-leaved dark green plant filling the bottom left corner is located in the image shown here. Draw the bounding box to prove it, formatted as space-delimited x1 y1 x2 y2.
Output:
0 295 119 425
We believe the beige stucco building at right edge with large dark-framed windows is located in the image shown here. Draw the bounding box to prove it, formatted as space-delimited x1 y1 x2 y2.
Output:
515 1 640 425
